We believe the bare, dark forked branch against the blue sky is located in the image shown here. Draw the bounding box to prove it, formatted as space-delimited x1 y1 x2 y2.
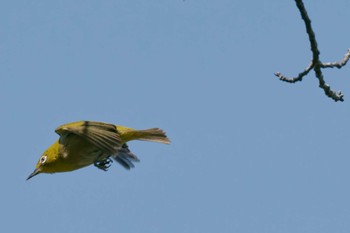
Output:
275 0 350 101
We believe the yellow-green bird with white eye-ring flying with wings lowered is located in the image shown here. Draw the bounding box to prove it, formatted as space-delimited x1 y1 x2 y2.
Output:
27 121 170 180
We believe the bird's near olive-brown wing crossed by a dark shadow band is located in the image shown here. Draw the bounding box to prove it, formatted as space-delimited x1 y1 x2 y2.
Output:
55 121 122 154
